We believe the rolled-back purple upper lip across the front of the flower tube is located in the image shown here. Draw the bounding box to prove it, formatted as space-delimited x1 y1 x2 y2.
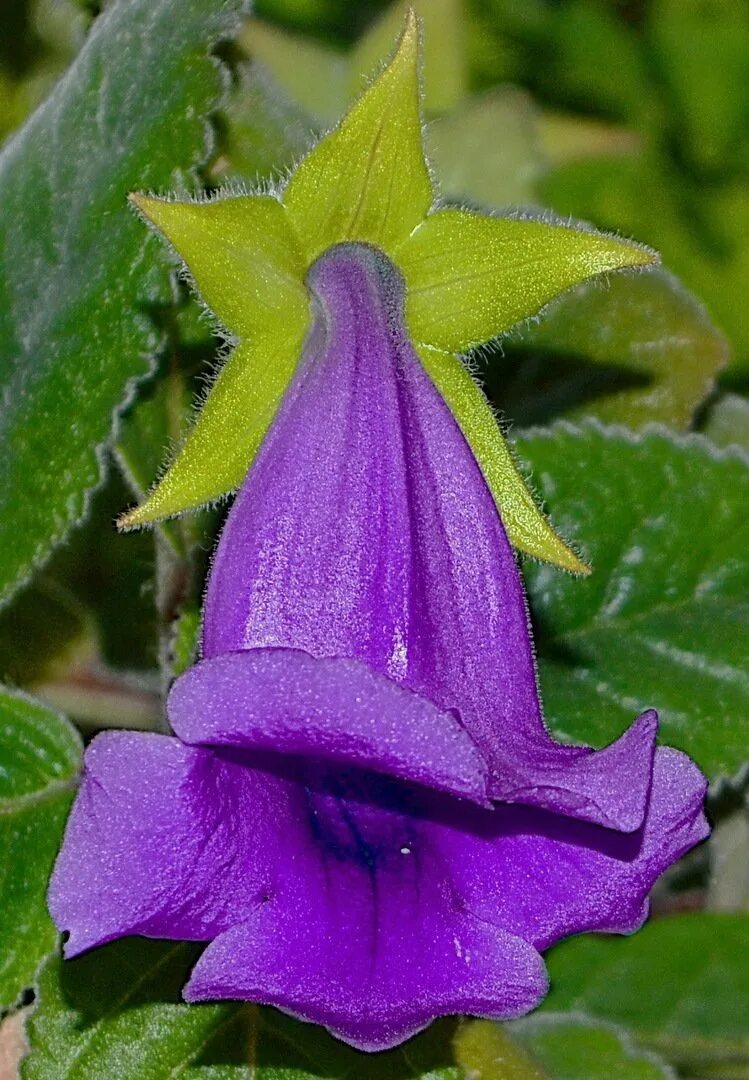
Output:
167 649 487 804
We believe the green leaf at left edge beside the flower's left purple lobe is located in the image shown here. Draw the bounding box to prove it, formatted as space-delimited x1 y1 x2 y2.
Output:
0 687 81 1011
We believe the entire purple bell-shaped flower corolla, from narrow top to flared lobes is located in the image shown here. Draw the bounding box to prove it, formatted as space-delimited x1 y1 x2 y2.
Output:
50 242 707 1051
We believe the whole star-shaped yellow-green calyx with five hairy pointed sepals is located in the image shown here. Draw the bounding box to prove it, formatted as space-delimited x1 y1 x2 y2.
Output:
121 12 655 572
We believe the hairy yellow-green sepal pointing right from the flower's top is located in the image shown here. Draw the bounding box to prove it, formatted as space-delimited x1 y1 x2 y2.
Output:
396 210 656 352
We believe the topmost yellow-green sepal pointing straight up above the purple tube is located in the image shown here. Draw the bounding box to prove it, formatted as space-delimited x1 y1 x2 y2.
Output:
283 12 434 260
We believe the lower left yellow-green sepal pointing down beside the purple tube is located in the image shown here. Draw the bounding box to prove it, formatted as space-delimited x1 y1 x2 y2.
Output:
118 323 307 528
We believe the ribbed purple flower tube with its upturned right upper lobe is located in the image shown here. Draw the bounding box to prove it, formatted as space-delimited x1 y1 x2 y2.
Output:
203 244 653 831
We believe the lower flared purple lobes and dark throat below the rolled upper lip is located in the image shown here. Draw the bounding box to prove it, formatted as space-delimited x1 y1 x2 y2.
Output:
50 732 706 1050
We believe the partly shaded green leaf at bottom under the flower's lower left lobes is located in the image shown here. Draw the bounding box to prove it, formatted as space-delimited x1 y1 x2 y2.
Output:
22 937 460 1080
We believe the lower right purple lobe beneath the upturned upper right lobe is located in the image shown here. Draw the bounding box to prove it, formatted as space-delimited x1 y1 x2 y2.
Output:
430 748 709 949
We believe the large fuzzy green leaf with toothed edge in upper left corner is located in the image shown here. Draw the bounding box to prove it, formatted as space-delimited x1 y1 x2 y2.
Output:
0 0 249 598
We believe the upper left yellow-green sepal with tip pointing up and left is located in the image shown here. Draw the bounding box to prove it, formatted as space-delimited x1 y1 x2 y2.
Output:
131 194 308 338
